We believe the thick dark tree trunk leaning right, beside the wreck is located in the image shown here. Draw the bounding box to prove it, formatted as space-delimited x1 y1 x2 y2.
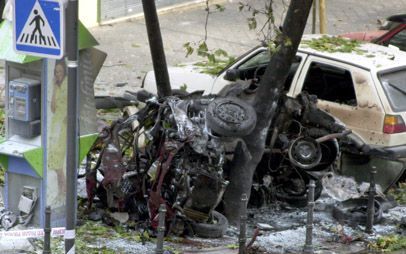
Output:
224 0 313 224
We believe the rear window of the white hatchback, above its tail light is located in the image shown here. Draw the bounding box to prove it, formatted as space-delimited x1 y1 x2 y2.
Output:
379 69 406 112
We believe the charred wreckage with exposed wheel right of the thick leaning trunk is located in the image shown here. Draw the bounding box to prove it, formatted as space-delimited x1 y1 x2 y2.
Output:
250 93 349 206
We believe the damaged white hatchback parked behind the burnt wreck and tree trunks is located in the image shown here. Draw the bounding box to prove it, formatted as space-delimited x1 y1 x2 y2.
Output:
143 35 406 149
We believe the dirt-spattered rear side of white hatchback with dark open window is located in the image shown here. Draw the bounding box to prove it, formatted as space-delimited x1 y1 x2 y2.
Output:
294 56 385 144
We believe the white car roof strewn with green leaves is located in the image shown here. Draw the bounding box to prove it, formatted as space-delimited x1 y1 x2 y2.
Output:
299 35 406 71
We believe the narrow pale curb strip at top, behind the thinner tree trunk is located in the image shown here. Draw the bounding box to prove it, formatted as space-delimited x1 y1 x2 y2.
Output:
99 0 229 26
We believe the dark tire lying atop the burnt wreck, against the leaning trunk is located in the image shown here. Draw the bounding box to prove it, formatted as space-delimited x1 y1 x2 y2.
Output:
206 97 257 137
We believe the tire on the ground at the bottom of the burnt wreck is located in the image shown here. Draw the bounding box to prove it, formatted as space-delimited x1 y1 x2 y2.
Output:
192 211 228 238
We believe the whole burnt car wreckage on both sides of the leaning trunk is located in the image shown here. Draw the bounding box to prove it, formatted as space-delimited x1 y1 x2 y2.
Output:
86 92 348 237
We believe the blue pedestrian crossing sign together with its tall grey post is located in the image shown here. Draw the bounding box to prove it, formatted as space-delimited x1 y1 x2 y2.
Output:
13 0 79 251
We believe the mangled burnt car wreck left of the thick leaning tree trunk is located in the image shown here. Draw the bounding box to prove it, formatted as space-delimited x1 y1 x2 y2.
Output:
86 92 255 237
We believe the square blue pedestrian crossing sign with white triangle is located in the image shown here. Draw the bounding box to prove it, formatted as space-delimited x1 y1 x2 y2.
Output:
13 0 65 59
